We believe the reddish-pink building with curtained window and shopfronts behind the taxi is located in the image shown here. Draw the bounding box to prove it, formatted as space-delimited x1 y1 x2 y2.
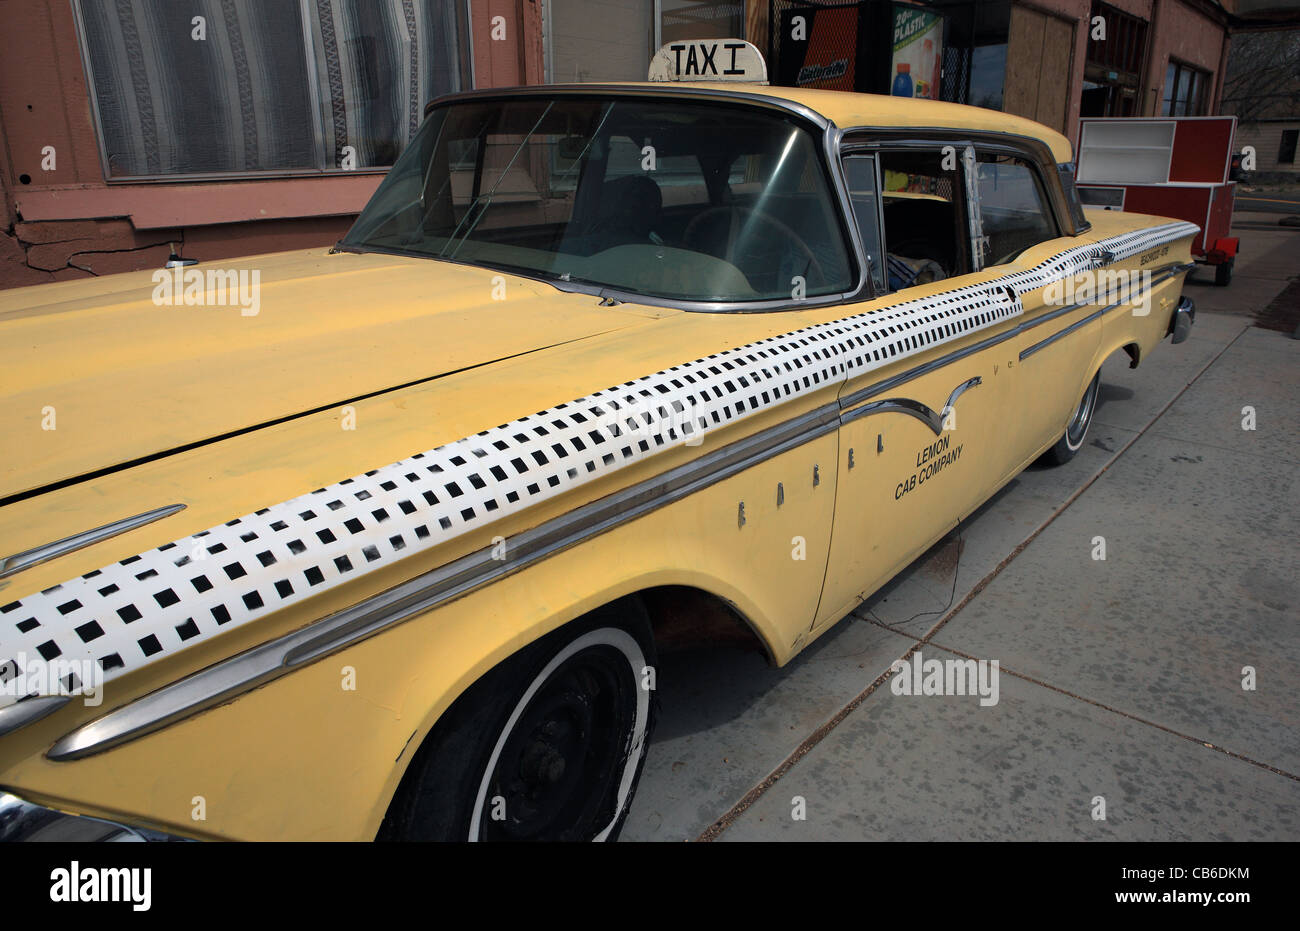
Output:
0 0 1295 287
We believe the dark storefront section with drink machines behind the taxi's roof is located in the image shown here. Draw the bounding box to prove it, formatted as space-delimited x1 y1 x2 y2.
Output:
750 0 1230 137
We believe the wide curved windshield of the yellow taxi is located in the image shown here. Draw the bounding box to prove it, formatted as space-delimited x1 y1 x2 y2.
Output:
341 96 854 302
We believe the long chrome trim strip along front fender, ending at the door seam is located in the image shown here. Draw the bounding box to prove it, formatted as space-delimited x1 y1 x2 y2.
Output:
48 403 840 762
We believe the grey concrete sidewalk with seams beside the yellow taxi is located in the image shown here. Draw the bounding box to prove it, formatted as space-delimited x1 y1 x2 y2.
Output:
623 214 1300 840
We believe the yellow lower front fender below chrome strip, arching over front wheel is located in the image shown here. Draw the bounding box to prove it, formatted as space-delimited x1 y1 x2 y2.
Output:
0 433 837 840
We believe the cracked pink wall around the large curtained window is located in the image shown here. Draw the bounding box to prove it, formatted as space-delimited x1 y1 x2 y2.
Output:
0 0 543 287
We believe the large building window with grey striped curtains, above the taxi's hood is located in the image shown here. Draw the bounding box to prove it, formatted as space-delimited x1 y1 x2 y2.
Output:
75 0 471 179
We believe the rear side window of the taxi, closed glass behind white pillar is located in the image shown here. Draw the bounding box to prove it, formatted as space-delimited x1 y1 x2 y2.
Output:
975 153 1057 265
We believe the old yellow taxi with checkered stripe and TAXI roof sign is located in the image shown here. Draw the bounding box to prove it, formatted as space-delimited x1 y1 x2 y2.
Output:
0 43 1196 840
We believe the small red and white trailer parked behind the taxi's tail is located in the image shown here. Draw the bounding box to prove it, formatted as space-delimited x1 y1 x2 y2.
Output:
1075 117 1239 285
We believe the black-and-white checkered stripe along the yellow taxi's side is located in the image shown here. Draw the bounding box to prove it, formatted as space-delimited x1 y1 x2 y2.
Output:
0 224 1196 703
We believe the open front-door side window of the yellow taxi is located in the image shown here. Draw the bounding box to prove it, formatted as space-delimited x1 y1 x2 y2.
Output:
879 146 970 291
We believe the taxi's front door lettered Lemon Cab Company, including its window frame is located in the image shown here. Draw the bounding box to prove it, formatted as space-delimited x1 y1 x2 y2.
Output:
814 140 1022 628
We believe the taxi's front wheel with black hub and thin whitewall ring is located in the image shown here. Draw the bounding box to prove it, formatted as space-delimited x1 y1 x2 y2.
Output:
380 599 655 841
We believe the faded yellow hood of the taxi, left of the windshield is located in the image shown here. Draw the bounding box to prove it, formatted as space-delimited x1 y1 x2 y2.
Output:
0 250 645 501
